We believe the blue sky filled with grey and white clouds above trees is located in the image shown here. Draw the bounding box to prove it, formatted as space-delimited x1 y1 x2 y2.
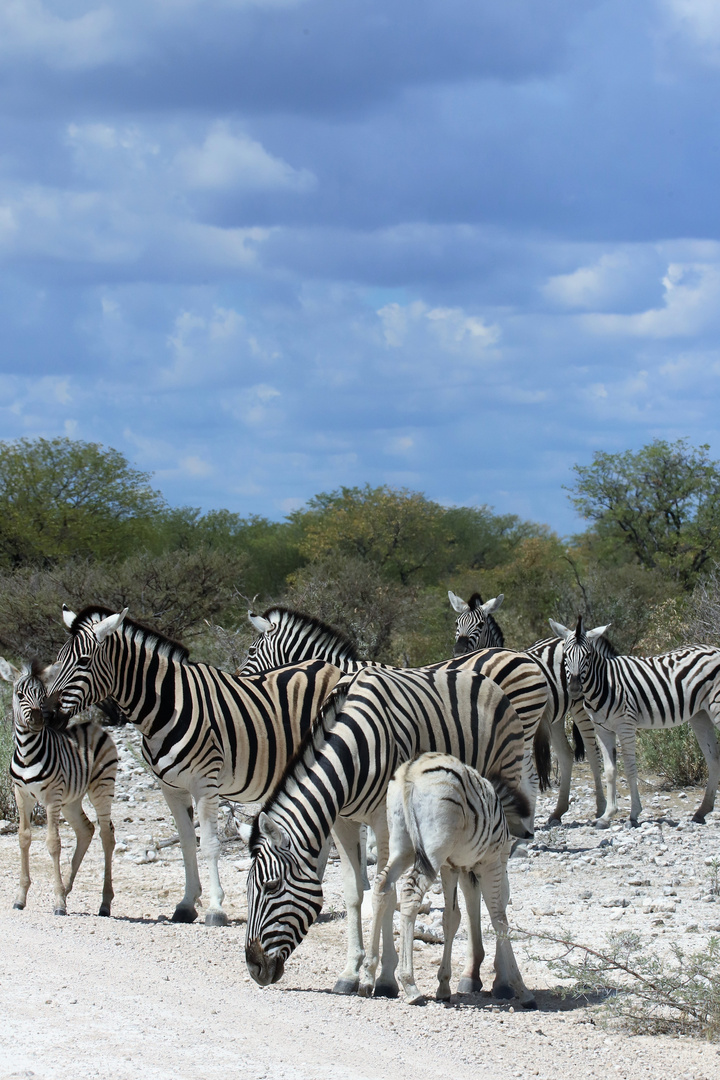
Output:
0 0 720 534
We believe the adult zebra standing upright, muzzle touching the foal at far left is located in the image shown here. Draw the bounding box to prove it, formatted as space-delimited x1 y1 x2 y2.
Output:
44 606 341 926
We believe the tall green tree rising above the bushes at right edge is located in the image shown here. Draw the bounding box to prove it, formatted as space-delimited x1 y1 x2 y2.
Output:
570 438 720 590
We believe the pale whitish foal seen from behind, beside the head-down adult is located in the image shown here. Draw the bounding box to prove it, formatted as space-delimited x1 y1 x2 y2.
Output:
366 753 535 1009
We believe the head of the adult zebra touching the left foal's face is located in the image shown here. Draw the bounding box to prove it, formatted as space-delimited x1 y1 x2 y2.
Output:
42 605 127 728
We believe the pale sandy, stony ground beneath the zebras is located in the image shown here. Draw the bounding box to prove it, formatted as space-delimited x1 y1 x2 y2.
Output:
0 730 720 1080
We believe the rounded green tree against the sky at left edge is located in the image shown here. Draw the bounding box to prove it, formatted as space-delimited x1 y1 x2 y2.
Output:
0 438 165 567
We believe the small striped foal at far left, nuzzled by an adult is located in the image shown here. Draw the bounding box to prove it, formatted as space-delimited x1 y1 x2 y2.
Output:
0 657 118 915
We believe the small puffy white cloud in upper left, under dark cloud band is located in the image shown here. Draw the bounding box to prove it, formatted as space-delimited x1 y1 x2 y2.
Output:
175 122 315 191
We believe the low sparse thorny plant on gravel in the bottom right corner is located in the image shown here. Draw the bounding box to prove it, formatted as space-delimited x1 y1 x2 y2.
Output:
518 931 720 1040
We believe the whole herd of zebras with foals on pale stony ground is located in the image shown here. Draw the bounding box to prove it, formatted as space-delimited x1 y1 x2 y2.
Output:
0 593 720 1008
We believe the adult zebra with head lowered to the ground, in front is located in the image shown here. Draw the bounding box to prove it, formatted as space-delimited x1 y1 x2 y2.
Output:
246 665 527 997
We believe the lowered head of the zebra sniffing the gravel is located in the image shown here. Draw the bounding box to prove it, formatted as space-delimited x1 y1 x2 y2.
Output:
245 812 323 986
